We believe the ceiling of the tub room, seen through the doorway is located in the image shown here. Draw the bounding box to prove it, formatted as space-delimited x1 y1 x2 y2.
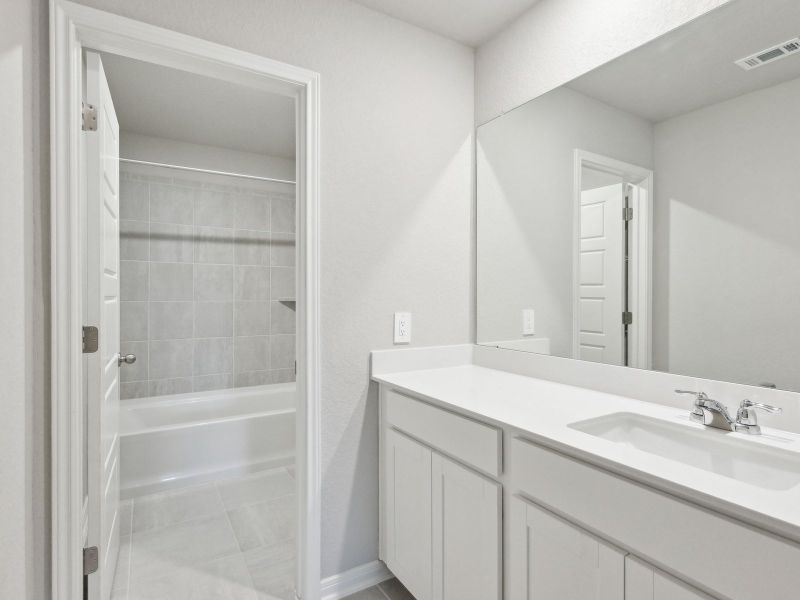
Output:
102 53 295 159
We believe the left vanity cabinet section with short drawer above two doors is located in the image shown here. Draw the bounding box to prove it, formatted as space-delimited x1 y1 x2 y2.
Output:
381 392 502 600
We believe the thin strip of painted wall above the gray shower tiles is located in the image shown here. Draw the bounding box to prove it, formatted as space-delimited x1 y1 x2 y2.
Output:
119 131 295 181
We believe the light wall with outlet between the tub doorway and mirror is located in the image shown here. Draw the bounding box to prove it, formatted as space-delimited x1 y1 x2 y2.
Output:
72 0 474 576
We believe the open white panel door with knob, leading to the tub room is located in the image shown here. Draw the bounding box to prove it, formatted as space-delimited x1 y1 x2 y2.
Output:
83 52 120 600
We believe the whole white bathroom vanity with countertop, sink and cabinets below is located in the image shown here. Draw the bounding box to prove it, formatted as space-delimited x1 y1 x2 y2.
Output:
372 346 800 600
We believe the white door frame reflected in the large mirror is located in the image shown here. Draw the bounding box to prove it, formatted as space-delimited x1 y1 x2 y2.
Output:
572 148 653 369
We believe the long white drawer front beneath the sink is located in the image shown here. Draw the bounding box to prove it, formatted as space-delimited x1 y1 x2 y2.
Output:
509 438 800 600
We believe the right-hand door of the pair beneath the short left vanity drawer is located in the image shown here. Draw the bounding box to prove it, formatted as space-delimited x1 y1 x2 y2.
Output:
433 453 502 600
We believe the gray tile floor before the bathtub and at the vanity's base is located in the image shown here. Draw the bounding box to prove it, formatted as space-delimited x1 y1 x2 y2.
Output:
112 467 414 600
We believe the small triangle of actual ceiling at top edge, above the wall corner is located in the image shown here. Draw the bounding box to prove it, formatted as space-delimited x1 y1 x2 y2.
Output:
355 0 537 46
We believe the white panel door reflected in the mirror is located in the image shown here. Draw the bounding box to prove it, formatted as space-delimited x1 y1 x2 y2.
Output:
577 183 625 365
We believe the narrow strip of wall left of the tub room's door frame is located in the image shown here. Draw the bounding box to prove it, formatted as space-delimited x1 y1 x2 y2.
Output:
0 0 49 599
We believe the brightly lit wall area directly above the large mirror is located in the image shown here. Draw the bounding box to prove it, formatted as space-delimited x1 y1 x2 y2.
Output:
476 0 730 123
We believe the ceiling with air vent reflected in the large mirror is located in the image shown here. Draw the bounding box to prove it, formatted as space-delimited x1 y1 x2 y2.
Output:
567 0 800 123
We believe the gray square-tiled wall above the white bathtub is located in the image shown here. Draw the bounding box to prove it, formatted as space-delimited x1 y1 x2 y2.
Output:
120 170 295 399
